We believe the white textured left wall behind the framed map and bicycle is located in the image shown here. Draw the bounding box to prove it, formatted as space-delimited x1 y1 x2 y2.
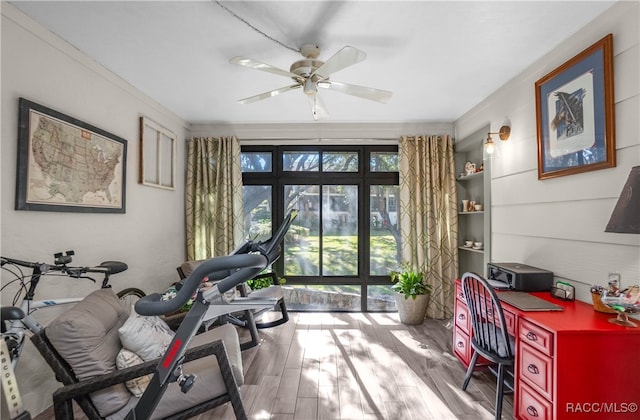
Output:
0 2 186 415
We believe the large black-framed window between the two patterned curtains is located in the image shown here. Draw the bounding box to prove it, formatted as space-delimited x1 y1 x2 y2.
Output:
242 146 400 311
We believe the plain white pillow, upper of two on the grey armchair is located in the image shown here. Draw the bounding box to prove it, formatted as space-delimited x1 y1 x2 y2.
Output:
118 311 175 362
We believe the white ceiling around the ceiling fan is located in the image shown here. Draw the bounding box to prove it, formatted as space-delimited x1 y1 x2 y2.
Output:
12 1 614 123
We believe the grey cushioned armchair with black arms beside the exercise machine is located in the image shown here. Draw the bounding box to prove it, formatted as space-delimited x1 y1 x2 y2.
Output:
31 289 246 420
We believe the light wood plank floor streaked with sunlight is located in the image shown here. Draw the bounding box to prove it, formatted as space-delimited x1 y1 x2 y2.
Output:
35 312 513 420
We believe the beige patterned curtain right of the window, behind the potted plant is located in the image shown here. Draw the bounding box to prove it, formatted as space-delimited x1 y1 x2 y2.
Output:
398 136 458 319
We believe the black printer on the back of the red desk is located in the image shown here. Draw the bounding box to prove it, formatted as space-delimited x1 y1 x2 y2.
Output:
487 263 553 292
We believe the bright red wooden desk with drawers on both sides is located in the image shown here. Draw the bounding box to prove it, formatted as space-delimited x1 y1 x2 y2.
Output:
453 280 640 420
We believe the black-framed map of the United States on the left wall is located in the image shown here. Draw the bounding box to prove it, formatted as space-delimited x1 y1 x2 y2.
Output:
16 98 127 213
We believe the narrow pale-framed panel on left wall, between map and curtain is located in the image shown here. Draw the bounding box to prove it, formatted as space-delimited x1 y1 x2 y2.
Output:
139 117 177 190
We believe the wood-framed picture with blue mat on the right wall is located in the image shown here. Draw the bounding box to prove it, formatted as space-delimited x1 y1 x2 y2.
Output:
535 34 616 179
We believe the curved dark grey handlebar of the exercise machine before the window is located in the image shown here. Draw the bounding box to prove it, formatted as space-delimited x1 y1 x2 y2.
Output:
135 254 269 316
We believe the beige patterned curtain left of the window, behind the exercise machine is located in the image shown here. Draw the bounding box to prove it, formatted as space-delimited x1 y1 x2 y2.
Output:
185 137 243 260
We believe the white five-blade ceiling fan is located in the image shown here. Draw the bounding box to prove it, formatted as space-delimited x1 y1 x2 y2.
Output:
229 44 392 120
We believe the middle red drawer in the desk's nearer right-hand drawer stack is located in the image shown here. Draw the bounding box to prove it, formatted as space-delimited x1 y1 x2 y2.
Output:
517 343 553 399
